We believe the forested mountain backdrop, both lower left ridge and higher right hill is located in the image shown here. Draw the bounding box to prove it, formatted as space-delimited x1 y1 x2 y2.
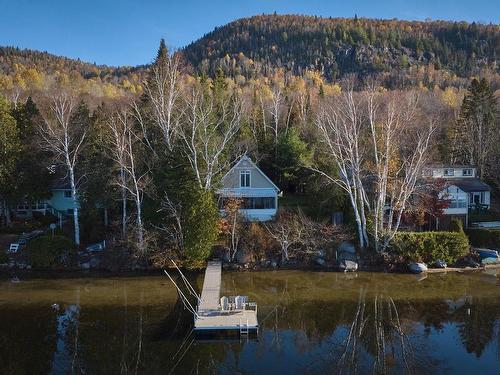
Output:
0 14 500 100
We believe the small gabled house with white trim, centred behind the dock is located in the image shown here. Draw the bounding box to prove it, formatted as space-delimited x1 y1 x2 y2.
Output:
217 155 280 221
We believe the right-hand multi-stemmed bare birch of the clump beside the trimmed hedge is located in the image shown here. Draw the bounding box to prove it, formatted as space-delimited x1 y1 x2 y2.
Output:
366 89 435 251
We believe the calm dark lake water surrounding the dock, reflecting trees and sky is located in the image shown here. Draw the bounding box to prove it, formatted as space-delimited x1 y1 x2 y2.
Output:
0 271 500 374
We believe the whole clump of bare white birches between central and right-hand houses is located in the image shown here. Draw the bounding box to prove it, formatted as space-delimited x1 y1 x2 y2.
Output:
312 83 435 251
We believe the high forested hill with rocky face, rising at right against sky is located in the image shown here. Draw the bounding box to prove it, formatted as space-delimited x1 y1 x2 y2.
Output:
184 15 500 79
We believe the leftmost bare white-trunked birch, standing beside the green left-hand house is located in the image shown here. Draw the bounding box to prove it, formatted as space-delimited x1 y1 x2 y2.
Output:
40 90 87 245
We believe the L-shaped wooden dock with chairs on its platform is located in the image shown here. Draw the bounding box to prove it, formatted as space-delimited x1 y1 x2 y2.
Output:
194 261 259 334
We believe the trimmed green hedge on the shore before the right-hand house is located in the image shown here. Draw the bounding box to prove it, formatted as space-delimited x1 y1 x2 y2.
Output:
392 231 469 264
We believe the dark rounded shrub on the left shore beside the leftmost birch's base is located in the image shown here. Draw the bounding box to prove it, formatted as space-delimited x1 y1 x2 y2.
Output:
28 235 77 268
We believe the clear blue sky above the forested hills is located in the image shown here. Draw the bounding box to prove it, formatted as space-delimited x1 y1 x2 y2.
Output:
0 0 500 65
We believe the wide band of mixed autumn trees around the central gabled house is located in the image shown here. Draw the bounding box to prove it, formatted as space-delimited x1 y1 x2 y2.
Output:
0 41 500 266
